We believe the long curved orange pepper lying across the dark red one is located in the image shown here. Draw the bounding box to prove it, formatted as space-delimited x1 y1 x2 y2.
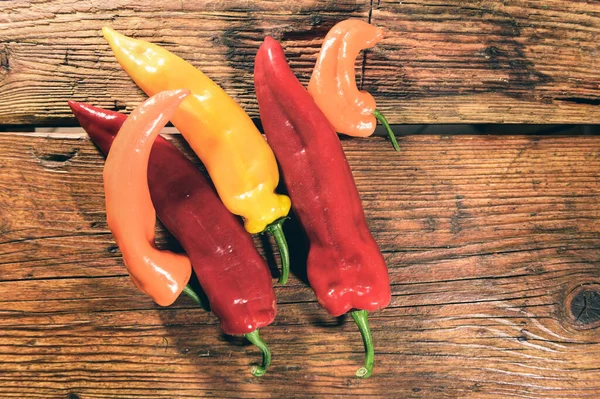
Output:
103 90 192 306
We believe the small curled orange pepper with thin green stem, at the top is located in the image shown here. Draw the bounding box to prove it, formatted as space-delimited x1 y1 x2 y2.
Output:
308 19 400 151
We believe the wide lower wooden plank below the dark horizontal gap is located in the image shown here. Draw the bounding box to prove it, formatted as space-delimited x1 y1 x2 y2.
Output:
0 133 600 399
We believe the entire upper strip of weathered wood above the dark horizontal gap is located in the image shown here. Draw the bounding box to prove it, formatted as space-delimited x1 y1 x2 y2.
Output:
0 0 600 125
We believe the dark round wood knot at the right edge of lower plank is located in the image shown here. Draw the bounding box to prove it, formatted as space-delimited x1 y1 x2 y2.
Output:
565 283 600 329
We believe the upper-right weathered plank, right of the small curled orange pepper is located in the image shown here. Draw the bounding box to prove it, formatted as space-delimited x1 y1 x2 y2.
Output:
364 0 600 123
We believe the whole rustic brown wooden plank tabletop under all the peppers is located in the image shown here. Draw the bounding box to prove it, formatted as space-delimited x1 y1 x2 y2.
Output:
0 0 600 399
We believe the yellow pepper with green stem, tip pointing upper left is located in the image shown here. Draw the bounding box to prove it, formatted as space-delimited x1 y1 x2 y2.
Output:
102 27 290 284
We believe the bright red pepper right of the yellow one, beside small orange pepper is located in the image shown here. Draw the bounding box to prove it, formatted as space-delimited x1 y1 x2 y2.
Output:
254 37 391 377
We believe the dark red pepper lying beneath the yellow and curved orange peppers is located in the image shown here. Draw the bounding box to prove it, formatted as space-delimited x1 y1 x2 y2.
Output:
69 101 276 375
